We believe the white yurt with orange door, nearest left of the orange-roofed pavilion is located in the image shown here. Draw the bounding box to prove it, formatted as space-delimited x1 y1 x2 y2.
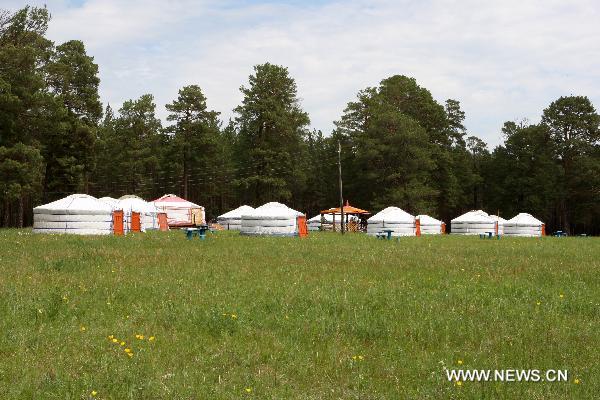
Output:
240 202 304 236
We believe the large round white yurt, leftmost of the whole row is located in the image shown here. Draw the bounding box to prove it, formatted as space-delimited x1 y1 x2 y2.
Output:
33 194 113 235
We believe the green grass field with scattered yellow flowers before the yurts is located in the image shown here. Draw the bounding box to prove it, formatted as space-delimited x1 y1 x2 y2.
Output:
0 230 600 399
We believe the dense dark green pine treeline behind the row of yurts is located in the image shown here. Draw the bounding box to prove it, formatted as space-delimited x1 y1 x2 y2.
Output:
0 7 600 234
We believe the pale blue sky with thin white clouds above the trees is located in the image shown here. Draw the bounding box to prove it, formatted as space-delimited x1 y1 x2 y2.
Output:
0 0 600 148
